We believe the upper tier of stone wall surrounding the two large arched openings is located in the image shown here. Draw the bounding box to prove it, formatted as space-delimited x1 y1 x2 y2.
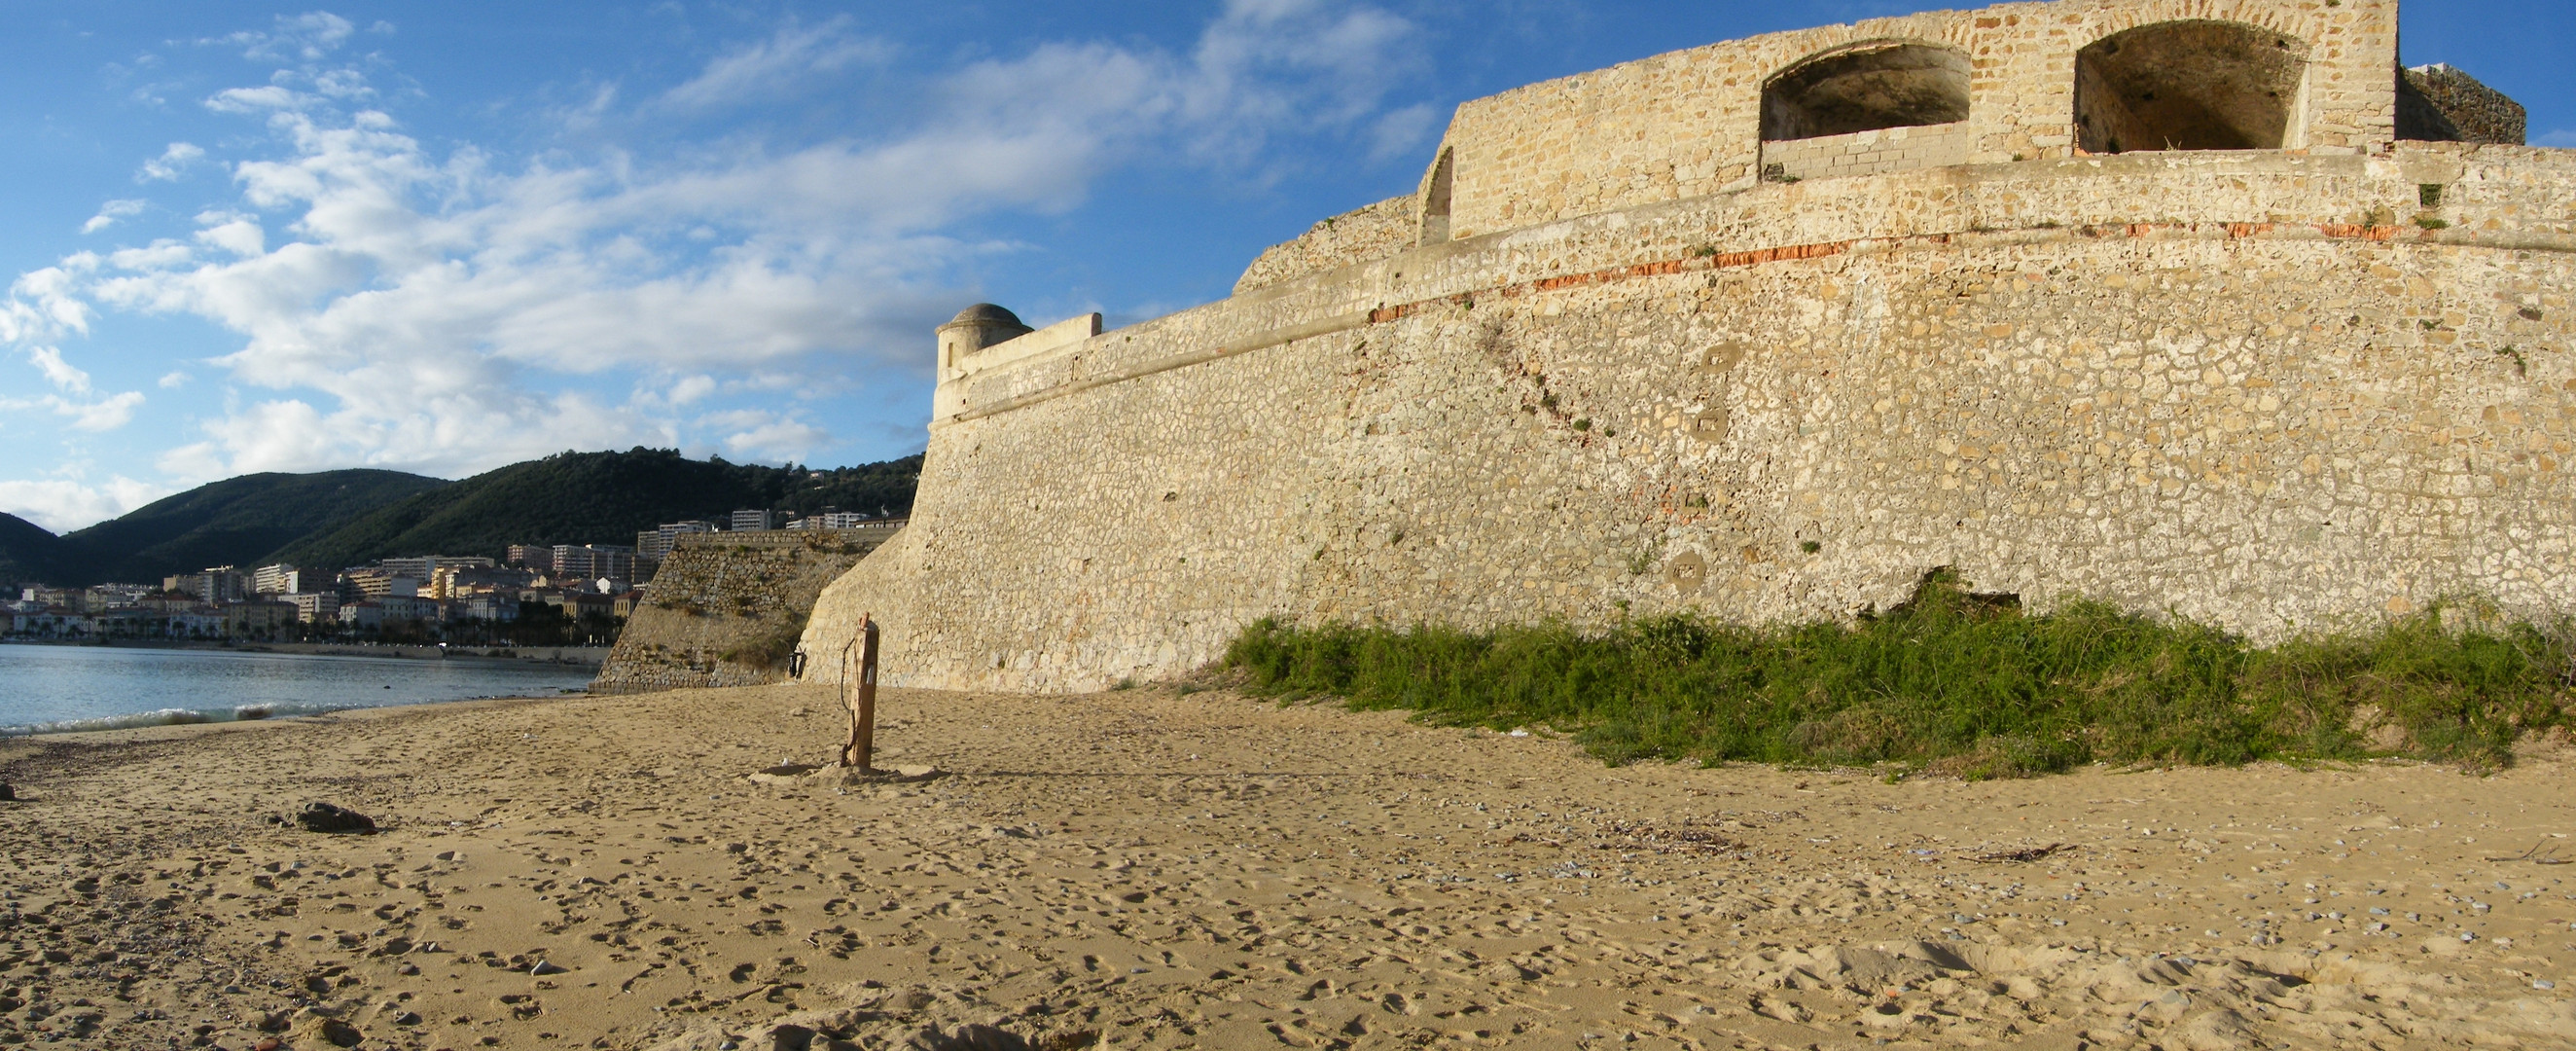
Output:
1424 0 2396 237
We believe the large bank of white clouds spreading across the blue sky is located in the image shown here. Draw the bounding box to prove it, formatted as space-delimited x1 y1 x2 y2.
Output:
0 0 1419 482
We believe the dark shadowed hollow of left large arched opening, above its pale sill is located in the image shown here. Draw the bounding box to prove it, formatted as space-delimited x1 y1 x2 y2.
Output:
1762 44 1968 142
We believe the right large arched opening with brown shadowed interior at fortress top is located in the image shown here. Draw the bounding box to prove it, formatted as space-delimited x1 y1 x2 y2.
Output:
2076 20 2308 152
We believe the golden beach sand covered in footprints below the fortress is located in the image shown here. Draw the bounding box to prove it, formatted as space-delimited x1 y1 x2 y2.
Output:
0 688 2576 1051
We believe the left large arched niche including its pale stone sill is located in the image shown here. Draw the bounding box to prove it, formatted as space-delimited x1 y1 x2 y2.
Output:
1762 41 1971 183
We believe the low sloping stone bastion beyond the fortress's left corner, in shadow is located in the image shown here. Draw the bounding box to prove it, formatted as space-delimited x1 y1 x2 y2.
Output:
590 528 899 693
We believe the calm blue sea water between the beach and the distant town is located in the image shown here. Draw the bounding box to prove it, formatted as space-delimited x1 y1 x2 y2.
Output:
0 644 595 734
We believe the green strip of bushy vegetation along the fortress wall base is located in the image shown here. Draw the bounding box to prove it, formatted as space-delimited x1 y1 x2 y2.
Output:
1224 572 2576 780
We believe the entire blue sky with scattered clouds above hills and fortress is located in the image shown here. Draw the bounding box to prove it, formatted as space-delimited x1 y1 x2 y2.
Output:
0 0 2576 530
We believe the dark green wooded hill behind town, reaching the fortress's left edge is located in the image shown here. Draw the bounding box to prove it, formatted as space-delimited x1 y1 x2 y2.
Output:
266 449 922 566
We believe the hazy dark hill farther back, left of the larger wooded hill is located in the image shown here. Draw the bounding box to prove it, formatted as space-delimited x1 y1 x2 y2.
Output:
59 469 448 585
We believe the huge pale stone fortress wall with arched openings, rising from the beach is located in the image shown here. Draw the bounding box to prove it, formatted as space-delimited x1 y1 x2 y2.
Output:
804 0 2576 690
